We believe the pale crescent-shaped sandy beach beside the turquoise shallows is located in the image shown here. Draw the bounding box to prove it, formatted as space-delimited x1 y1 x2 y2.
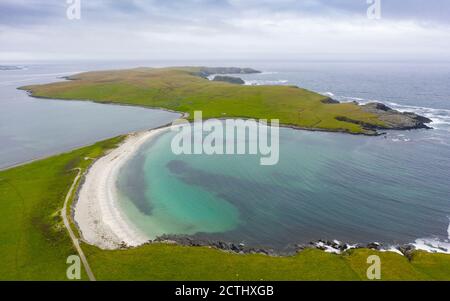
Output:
74 128 167 249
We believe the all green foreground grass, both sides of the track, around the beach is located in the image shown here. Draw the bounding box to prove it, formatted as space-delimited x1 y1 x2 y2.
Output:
0 138 450 280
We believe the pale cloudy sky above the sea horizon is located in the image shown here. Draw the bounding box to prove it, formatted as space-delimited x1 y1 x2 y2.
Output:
0 0 450 63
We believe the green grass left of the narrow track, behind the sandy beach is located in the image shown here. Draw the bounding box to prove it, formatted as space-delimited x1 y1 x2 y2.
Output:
0 139 120 280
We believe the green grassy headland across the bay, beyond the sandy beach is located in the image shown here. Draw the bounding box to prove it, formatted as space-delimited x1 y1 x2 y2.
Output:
22 67 383 134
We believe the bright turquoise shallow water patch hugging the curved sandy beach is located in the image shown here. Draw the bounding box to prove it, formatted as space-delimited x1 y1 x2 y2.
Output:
119 127 239 238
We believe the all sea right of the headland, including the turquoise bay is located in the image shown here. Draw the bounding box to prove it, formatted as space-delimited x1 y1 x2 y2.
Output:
118 63 450 252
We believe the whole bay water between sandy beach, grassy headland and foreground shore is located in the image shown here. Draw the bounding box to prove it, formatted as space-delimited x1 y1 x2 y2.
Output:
118 123 450 250
